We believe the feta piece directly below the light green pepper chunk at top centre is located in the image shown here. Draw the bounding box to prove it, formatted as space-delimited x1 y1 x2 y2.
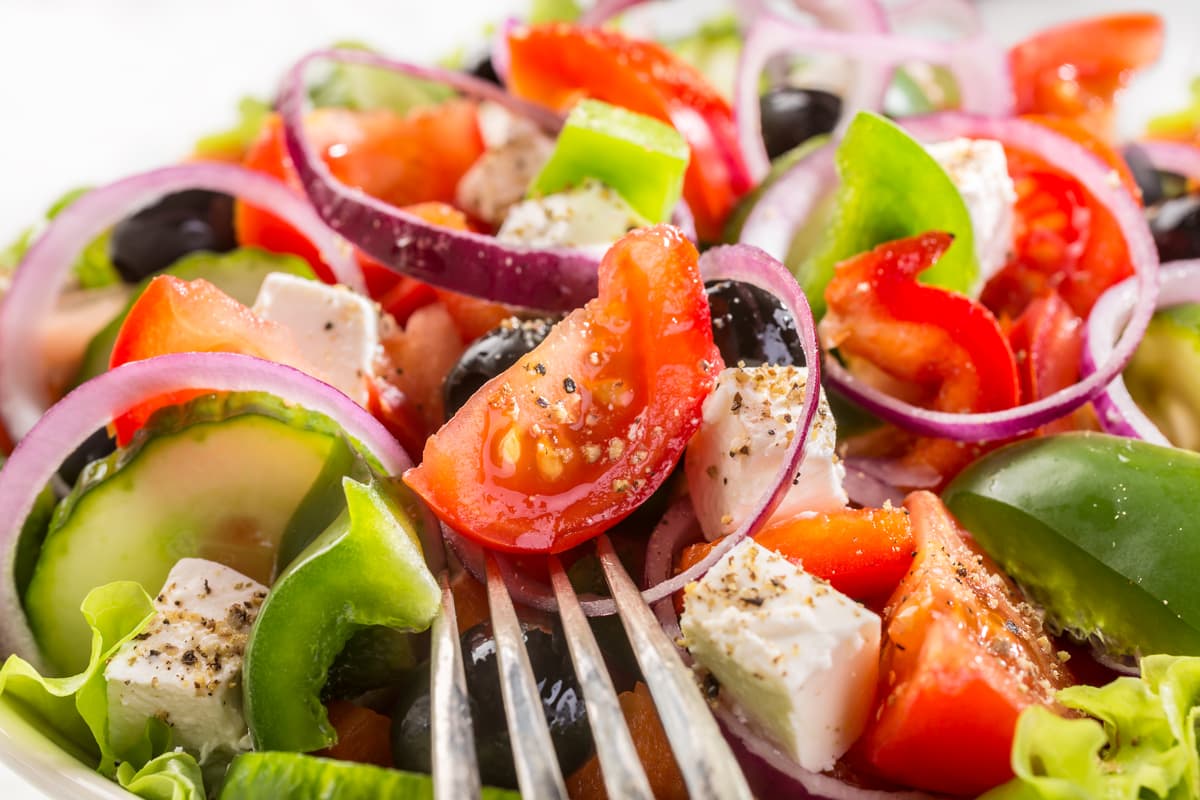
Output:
496 180 648 254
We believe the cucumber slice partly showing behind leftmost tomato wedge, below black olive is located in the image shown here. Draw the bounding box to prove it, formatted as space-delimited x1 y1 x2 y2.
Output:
74 247 317 386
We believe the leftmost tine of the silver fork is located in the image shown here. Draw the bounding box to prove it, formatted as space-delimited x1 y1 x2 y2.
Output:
430 571 481 800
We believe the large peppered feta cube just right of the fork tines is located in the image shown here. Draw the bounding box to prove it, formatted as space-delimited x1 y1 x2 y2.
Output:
680 540 882 772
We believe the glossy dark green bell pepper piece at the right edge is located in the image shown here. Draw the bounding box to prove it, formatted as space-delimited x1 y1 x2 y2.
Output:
943 433 1200 656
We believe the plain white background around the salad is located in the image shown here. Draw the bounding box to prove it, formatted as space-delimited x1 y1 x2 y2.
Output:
0 0 1200 799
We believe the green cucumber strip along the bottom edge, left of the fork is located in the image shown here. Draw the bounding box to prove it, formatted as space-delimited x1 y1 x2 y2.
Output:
220 752 521 800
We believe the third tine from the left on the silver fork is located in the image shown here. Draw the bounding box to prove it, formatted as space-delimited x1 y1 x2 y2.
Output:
550 558 654 800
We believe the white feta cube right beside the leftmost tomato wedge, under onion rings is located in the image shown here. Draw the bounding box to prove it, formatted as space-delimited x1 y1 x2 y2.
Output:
254 272 379 405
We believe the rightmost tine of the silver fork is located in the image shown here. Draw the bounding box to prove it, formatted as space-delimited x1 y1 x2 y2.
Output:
596 536 752 800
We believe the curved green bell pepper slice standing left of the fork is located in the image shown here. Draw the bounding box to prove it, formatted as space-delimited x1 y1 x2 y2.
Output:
242 477 442 752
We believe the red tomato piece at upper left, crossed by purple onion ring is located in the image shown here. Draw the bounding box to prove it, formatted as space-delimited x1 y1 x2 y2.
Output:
234 101 484 286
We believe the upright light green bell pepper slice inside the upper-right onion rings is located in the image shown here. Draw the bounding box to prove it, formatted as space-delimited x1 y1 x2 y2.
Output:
790 112 979 319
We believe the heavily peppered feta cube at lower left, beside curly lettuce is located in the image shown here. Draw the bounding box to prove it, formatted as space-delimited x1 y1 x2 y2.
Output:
104 559 266 763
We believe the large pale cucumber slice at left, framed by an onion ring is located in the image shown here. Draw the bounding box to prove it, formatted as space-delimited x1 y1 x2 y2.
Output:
24 393 344 674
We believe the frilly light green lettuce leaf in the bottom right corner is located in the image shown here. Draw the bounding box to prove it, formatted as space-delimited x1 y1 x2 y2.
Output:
984 656 1200 800
